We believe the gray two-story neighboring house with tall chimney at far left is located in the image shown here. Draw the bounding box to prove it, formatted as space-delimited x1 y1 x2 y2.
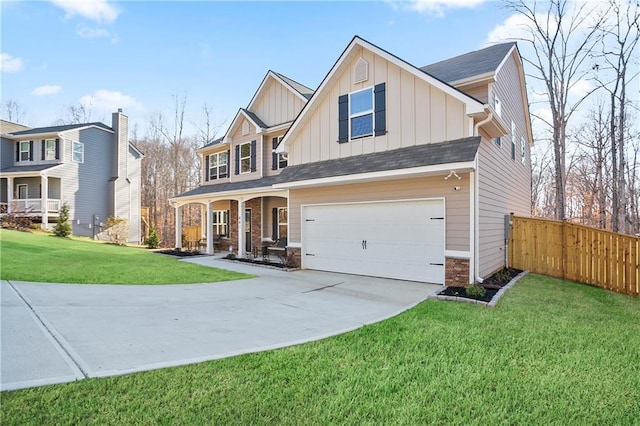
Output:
0 110 143 243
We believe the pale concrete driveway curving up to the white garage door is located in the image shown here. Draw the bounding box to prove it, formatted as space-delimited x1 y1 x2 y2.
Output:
0 257 441 390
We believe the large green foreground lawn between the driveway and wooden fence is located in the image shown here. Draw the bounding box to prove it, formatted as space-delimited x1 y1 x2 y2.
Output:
0 275 640 425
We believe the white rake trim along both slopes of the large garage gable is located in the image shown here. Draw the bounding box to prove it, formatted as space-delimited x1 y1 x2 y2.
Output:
277 36 484 152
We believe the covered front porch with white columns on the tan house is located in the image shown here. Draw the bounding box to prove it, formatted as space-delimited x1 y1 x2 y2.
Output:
173 188 288 262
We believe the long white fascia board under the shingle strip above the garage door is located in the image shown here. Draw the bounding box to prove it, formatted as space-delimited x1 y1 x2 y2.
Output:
273 161 475 189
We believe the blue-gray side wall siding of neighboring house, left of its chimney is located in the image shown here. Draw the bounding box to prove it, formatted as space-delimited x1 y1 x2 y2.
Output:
48 128 114 237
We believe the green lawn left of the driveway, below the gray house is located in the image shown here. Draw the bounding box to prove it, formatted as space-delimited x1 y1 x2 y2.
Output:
0 229 250 284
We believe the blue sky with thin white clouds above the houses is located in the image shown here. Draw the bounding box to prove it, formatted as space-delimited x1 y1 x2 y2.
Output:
0 0 510 136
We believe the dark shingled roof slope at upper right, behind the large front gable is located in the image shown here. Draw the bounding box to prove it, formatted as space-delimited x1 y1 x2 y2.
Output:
420 42 516 83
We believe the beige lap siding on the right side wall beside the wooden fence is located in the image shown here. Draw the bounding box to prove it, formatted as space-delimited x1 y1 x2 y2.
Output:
478 52 531 277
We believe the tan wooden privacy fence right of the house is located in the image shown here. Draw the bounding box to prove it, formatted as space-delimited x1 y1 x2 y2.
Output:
509 216 640 296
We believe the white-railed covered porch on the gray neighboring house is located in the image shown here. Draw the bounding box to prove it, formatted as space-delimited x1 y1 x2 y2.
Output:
0 171 62 229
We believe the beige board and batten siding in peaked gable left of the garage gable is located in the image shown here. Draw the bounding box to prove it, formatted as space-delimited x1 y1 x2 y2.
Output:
251 77 306 126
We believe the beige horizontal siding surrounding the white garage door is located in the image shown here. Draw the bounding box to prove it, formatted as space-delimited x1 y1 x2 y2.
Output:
289 174 469 251
